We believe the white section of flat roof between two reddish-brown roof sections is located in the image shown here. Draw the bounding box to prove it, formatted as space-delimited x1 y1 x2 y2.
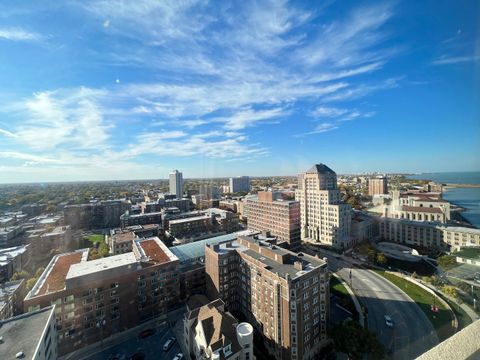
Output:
65 252 137 280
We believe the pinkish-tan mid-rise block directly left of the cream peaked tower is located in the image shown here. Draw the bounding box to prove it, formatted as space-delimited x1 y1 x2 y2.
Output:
245 191 300 249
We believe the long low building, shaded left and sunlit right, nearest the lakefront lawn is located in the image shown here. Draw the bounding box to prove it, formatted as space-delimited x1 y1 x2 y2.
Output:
378 217 480 250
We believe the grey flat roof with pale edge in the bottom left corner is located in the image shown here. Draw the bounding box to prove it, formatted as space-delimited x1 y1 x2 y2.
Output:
0 306 53 359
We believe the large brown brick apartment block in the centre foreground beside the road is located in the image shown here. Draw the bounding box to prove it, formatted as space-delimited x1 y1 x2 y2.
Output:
205 235 329 360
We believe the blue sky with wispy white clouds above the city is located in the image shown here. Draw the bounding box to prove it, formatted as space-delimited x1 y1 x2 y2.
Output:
0 0 480 182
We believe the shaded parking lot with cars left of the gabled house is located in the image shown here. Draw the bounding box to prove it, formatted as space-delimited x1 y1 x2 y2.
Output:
90 324 181 360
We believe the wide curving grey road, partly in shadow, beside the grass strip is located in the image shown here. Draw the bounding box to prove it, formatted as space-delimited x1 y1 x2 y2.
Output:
304 248 438 360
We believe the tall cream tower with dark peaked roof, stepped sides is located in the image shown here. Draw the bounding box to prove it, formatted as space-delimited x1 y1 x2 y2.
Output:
295 164 352 249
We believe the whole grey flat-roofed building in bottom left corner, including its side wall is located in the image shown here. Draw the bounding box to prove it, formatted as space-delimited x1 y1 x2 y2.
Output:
0 306 58 360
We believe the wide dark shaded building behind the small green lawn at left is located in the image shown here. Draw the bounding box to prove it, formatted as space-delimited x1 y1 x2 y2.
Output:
63 200 131 230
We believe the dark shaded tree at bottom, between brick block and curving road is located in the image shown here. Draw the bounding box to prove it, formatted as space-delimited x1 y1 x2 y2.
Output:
332 321 385 360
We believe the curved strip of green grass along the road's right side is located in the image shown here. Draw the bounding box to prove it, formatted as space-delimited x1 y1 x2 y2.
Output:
374 270 454 341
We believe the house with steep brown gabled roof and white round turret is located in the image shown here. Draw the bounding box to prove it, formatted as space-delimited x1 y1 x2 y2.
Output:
183 299 253 360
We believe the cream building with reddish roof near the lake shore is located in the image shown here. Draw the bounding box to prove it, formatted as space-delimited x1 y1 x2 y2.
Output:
383 190 450 223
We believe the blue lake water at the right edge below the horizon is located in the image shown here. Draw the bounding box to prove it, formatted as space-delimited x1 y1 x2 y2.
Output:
408 171 480 228
